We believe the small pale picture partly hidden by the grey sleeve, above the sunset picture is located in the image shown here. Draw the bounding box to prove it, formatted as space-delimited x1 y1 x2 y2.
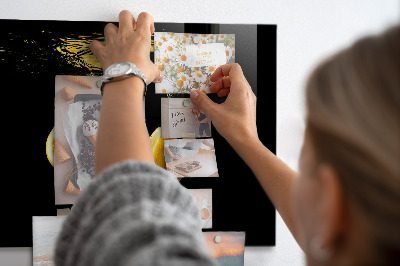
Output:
189 189 212 228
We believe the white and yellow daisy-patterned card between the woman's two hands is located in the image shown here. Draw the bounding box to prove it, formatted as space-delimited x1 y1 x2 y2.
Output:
154 32 235 93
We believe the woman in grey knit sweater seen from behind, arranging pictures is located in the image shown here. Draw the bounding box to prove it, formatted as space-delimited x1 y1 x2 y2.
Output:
55 11 400 266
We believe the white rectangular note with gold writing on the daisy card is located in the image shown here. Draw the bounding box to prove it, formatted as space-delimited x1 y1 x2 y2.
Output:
185 43 226 67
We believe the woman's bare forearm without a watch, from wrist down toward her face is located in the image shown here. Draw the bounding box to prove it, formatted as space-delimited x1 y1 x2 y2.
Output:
231 138 297 239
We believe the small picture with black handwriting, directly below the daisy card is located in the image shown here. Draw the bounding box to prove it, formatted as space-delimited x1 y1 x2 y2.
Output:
161 98 211 139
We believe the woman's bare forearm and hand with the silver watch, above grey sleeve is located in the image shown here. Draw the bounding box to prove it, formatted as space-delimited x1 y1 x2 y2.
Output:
90 10 163 176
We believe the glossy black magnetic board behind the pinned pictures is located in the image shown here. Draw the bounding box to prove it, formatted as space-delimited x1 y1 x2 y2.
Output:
0 20 277 247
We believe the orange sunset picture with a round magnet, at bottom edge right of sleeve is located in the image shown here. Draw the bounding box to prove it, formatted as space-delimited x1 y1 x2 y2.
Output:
203 232 245 266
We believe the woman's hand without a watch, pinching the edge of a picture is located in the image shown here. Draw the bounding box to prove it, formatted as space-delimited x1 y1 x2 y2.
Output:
190 63 258 146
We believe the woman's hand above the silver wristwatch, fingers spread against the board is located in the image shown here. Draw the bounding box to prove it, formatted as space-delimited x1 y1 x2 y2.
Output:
90 10 163 83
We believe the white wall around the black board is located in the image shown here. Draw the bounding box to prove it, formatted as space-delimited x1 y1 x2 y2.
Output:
0 0 400 266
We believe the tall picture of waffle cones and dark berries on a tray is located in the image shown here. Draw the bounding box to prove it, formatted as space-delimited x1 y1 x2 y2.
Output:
54 75 102 205
